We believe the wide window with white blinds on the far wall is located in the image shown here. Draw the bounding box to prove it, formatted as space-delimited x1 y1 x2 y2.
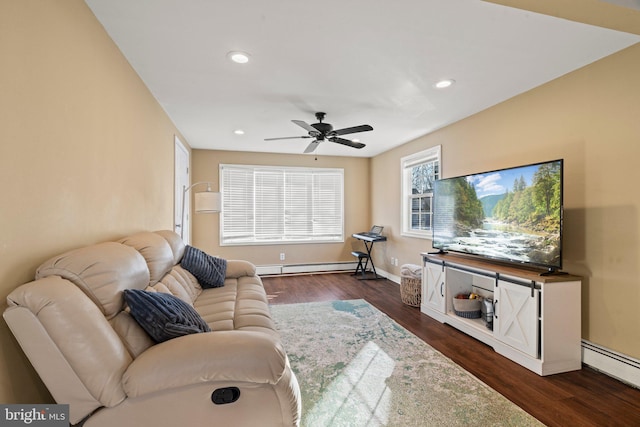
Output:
220 165 344 245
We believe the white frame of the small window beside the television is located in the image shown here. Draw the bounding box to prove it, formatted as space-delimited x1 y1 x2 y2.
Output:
400 145 442 239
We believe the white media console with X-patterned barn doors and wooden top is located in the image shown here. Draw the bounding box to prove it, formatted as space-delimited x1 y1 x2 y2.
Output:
420 253 582 375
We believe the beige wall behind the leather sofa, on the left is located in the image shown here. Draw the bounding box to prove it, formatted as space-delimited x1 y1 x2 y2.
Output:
0 0 182 403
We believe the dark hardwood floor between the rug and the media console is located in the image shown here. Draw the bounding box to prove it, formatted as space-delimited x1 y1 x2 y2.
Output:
263 273 640 427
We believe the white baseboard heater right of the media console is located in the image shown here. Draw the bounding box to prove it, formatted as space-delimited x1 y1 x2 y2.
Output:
582 340 640 388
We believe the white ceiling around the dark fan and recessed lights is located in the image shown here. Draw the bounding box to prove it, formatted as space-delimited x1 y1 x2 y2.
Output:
85 0 640 157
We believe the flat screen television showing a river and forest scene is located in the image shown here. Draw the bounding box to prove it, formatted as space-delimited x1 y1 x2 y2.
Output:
433 160 563 272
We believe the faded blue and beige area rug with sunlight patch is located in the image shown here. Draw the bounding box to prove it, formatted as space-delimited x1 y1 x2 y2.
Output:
271 300 542 427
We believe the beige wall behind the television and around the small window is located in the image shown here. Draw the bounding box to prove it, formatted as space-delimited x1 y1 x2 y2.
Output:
371 44 640 359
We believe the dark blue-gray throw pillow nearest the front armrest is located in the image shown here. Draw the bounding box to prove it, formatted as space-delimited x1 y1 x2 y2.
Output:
124 289 211 343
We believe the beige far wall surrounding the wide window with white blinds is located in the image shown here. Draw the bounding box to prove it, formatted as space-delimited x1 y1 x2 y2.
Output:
191 150 371 265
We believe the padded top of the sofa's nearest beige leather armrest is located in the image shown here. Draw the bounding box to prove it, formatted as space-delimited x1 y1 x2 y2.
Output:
123 331 288 397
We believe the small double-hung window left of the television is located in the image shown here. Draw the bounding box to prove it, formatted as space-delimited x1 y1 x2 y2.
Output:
400 145 440 239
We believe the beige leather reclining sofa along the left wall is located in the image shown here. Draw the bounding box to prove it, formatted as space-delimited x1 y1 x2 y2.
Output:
4 231 300 427
